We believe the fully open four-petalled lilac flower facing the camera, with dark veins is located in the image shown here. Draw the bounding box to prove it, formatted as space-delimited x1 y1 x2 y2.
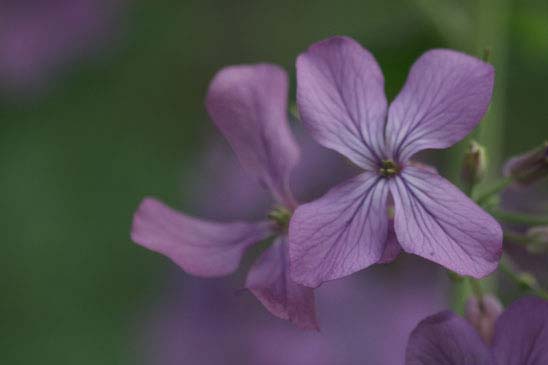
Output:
289 37 502 287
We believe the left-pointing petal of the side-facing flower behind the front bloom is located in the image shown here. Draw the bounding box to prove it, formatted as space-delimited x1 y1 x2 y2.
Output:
131 198 271 277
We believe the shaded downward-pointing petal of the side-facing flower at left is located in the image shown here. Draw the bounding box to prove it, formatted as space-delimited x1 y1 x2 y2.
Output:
245 237 318 330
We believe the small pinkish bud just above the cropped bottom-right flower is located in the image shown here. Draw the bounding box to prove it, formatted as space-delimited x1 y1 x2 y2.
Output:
464 295 503 344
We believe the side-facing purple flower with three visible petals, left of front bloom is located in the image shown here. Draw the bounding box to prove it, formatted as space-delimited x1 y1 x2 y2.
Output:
131 64 317 329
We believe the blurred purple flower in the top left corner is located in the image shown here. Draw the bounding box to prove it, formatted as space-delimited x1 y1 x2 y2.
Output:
0 0 122 91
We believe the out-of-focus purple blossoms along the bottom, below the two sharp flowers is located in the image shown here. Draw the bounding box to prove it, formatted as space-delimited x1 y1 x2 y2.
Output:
139 258 447 365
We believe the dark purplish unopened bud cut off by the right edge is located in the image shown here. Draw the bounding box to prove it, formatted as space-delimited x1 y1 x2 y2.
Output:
504 141 548 185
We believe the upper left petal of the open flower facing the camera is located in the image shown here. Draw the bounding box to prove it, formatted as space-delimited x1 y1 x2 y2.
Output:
297 37 387 170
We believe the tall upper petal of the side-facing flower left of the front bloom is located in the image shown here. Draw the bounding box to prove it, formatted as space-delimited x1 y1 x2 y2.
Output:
206 64 299 207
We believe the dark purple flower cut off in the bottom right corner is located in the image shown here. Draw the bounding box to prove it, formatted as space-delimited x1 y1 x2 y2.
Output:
406 298 548 365
